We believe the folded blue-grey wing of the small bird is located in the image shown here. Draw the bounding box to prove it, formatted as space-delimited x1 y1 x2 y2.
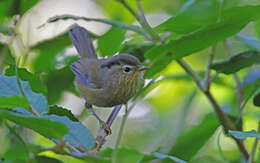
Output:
70 60 98 88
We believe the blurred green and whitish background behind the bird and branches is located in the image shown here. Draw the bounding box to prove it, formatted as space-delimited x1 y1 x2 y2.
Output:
0 0 260 163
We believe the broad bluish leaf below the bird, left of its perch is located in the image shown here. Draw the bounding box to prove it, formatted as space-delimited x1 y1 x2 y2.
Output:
43 114 96 150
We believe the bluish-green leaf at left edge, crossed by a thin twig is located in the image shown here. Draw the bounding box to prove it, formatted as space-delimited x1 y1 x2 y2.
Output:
0 75 48 114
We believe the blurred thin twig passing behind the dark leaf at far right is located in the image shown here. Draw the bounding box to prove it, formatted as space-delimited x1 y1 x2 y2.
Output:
223 40 243 120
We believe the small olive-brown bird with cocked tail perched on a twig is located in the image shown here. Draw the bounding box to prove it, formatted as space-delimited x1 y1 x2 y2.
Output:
69 25 148 132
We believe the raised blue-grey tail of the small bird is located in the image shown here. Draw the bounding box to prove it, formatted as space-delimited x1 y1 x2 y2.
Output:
69 26 97 58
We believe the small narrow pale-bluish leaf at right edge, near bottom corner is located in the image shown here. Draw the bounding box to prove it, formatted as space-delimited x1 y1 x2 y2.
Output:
228 130 260 140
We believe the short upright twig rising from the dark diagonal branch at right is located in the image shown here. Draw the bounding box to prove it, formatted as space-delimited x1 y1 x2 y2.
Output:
203 44 217 90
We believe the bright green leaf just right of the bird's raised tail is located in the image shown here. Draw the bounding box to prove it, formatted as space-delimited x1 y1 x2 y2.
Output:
98 28 126 56
